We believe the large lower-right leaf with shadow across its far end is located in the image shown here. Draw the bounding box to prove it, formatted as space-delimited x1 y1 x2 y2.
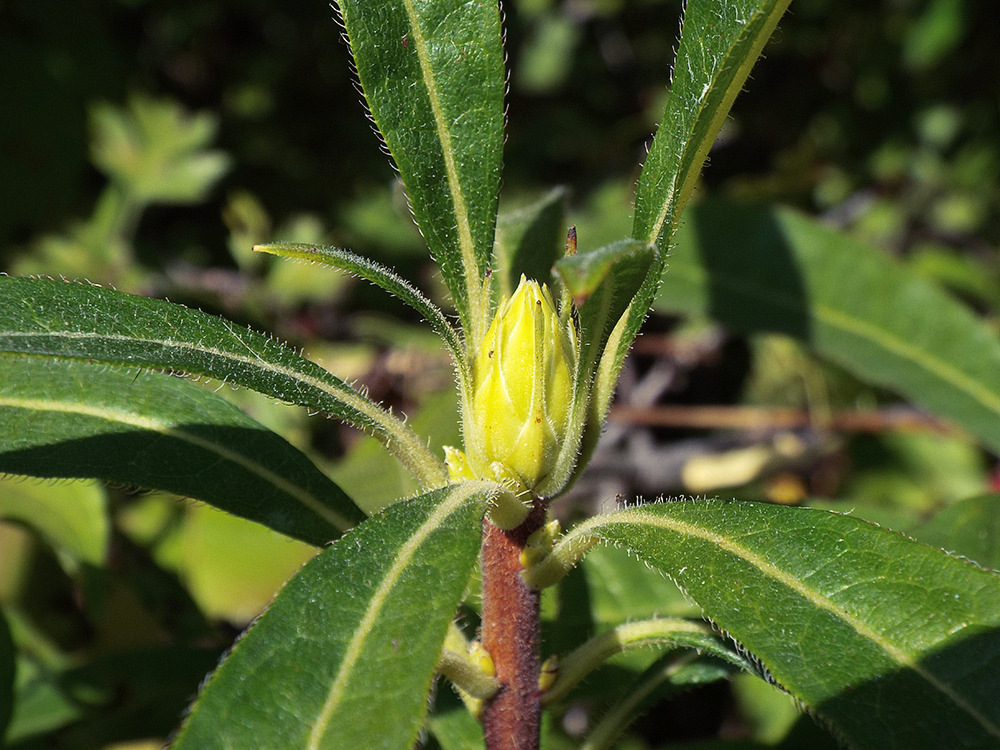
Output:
568 501 1000 750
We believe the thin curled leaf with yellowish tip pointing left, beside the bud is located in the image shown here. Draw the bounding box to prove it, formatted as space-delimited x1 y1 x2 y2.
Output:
254 242 467 374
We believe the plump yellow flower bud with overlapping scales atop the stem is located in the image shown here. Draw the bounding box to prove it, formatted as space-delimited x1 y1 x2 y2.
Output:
466 276 576 489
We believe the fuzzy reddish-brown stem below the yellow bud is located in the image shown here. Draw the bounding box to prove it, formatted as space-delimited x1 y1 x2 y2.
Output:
481 500 545 750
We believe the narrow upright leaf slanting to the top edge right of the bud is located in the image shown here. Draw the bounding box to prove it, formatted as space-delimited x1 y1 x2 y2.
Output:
619 0 790 384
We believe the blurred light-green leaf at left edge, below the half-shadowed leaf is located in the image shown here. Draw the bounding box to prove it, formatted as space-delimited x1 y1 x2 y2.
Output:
0 478 111 567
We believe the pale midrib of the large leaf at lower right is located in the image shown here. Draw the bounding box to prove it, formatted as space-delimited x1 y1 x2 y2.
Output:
580 511 1000 738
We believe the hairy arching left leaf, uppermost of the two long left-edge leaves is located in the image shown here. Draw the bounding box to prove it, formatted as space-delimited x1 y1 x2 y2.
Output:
0 277 447 486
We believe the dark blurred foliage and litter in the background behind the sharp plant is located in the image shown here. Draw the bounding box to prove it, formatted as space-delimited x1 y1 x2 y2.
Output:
0 0 1000 750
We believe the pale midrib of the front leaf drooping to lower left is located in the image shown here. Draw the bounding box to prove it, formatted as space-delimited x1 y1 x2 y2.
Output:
306 482 486 750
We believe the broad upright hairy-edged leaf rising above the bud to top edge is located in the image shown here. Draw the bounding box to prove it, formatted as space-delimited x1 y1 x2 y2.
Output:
338 0 506 342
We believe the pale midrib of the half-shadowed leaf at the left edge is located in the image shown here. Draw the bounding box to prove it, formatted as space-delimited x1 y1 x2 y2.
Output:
0 396 354 531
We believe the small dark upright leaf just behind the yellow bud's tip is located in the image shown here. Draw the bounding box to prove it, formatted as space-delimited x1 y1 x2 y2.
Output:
494 187 566 297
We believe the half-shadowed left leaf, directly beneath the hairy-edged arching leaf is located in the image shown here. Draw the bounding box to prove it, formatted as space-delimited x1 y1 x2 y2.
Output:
0 357 365 545
